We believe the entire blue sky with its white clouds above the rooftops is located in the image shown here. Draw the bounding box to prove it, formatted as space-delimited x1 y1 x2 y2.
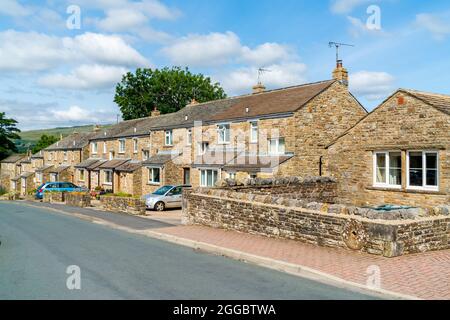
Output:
0 0 450 130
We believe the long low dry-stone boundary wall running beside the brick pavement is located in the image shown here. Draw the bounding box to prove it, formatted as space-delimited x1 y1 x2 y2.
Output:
183 189 450 257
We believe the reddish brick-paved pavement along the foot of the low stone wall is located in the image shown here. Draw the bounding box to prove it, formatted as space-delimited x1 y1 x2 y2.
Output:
157 226 450 300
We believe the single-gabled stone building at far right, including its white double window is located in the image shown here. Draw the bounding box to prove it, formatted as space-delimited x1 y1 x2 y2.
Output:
326 89 450 207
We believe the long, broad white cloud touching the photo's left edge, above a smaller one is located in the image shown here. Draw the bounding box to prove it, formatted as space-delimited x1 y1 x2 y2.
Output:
0 30 149 71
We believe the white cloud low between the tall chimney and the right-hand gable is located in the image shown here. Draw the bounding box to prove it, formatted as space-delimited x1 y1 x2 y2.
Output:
349 71 395 101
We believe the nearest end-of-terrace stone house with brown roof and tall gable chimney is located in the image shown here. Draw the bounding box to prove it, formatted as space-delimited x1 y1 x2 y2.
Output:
188 62 367 186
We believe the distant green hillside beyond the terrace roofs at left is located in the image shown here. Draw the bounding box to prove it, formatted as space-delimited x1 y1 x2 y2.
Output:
15 125 109 152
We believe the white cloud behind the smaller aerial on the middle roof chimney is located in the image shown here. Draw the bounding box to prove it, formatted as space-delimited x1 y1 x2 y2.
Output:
217 62 307 95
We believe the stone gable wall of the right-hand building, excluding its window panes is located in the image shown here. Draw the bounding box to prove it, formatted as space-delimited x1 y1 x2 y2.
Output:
324 92 450 206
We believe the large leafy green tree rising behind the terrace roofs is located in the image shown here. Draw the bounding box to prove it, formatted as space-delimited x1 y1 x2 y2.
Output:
114 67 226 120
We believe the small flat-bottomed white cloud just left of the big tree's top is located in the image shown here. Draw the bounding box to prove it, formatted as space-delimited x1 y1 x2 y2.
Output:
38 65 128 90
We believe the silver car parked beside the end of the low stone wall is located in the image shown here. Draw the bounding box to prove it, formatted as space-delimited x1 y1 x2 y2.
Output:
142 185 191 211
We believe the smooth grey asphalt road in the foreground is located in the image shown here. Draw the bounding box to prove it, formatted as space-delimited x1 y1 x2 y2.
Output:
0 202 378 300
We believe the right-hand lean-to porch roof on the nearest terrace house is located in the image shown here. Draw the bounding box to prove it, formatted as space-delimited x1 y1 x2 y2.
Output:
223 153 294 172
